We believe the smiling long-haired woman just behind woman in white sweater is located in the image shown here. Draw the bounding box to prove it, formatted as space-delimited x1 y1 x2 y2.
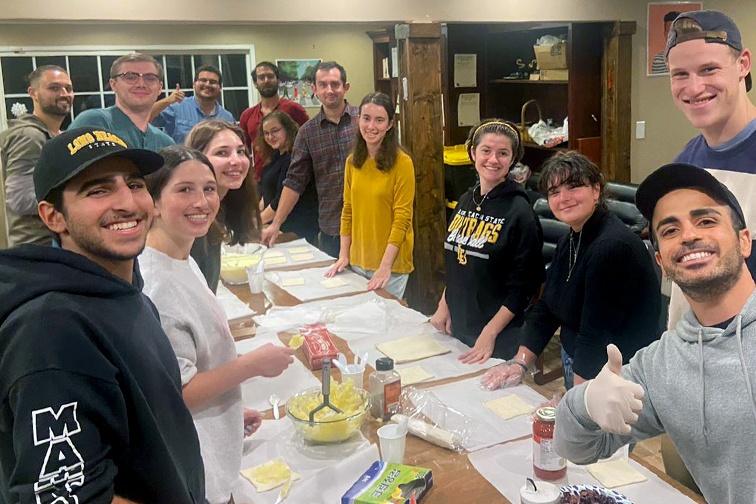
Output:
184 120 262 292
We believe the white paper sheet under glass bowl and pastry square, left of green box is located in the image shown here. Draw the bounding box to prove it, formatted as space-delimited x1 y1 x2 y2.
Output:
234 419 379 504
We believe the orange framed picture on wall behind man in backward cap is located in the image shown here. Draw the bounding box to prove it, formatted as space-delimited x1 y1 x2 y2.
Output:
646 2 703 76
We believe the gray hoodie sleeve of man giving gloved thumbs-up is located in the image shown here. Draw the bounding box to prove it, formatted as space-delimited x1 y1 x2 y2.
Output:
554 348 664 464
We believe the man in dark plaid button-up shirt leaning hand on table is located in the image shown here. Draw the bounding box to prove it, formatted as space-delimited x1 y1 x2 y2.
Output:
262 61 359 257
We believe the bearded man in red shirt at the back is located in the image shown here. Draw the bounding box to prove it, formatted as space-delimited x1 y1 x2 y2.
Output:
239 61 309 183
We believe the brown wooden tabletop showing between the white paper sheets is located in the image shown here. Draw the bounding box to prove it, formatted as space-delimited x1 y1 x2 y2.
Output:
228 274 705 504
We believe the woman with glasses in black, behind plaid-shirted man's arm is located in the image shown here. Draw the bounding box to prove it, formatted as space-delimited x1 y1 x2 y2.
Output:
255 110 319 246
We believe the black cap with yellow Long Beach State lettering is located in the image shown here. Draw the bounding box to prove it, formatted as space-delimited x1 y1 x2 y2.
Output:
34 126 163 201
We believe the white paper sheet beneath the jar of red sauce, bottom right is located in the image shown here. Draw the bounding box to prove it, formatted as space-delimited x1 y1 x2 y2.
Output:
468 439 694 504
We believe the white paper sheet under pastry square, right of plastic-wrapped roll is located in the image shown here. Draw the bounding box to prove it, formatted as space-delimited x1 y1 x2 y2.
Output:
422 377 547 451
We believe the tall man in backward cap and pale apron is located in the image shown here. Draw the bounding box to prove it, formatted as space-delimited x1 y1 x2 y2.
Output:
662 10 756 488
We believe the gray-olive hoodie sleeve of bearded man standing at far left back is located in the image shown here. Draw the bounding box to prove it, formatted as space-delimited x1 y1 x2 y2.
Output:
3 127 47 215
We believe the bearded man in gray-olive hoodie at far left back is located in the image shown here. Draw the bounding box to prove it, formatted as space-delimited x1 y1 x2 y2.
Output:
0 65 74 247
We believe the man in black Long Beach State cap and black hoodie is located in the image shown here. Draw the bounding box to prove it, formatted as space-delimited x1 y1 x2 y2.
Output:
0 127 204 503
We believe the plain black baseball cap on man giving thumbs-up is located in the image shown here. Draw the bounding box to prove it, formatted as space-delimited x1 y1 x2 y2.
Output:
635 163 745 223
